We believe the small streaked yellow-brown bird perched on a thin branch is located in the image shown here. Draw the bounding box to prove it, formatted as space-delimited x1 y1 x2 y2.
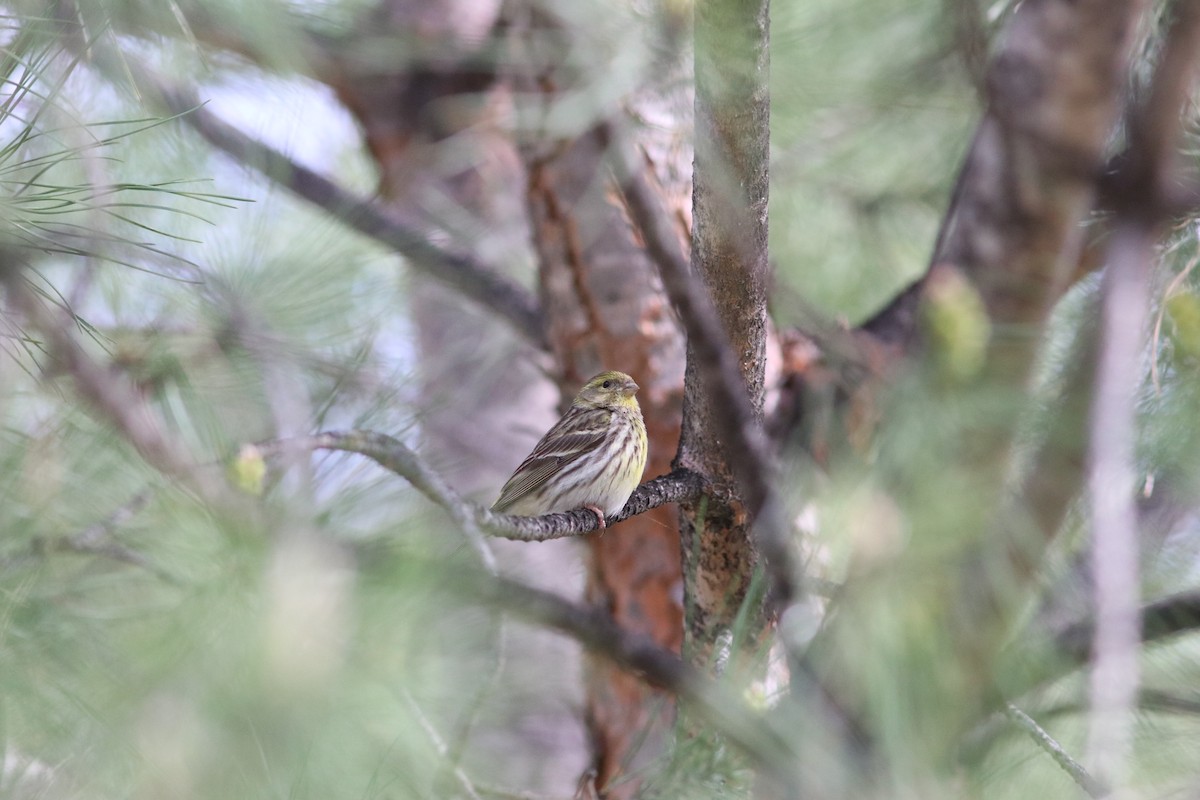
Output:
492 371 647 530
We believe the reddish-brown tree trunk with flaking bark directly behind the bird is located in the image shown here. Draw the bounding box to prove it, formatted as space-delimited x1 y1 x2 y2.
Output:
526 123 683 798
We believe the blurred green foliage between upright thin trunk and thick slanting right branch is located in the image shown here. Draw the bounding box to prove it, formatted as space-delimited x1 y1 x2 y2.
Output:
770 0 978 323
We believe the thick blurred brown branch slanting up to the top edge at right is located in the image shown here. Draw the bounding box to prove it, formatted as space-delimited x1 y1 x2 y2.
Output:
864 0 1147 357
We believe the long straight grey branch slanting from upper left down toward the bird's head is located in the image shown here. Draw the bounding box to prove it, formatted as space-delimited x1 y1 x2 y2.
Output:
67 17 546 347
